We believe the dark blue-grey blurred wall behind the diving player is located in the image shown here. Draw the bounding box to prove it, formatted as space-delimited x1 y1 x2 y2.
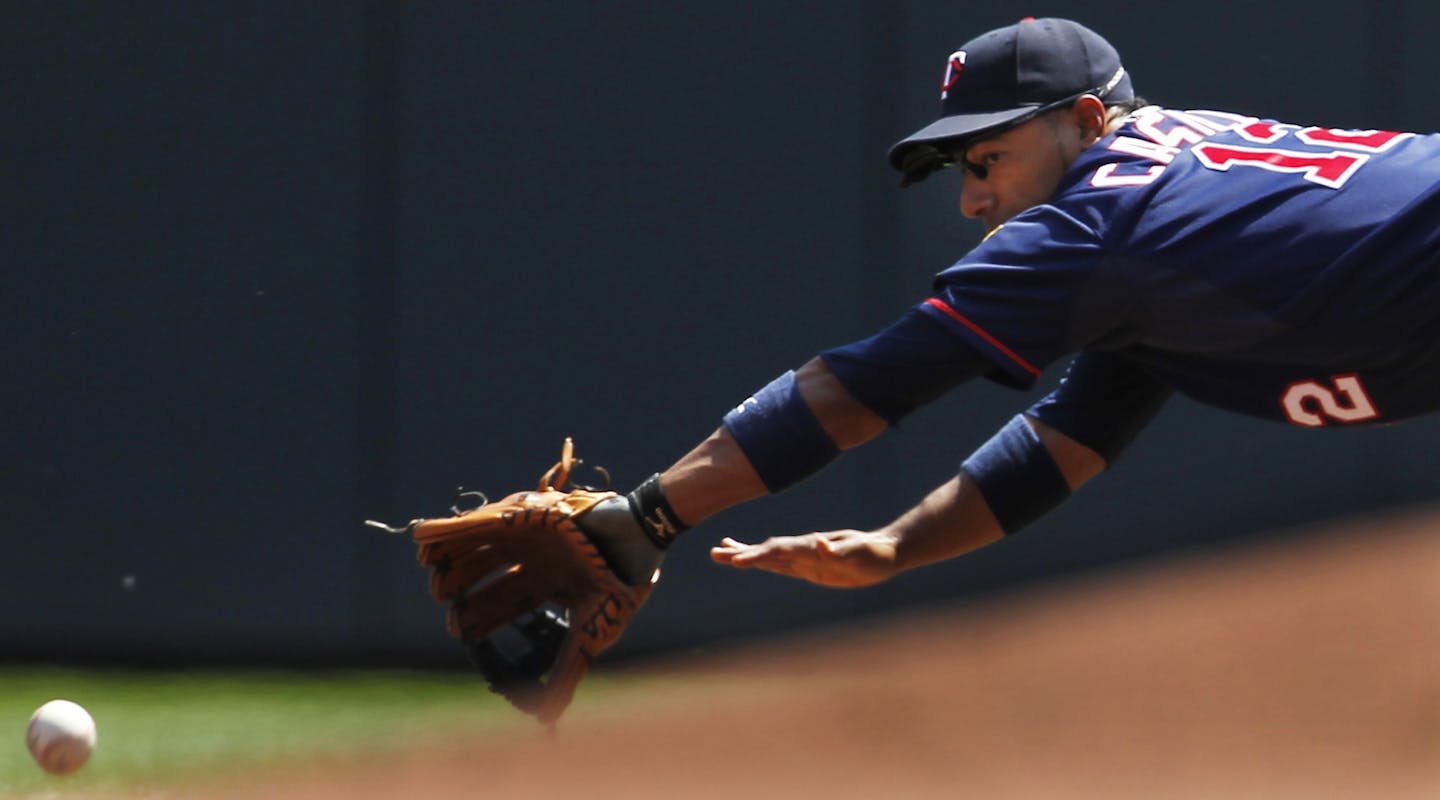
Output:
0 0 1440 665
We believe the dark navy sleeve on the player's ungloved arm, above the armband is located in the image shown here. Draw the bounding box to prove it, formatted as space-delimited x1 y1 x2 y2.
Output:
1025 351 1174 465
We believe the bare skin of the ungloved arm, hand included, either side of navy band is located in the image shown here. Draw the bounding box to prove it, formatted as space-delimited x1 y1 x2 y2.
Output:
710 420 1104 587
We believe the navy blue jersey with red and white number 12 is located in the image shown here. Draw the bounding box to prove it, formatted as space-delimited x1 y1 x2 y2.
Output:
919 106 1440 431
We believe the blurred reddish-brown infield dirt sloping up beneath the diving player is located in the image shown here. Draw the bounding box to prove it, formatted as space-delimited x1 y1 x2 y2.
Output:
197 515 1440 800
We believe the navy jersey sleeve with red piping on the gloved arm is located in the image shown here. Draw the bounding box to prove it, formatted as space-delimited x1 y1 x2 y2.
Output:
919 191 1133 388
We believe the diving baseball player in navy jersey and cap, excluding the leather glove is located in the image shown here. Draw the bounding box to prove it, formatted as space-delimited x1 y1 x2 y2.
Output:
380 19 1440 719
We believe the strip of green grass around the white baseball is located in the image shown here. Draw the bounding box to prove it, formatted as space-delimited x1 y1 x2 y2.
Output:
0 669 534 799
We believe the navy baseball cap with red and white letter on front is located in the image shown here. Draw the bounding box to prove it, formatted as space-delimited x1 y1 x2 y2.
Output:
890 17 1135 183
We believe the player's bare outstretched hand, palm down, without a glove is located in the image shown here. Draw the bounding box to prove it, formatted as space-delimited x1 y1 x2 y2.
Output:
710 531 897 588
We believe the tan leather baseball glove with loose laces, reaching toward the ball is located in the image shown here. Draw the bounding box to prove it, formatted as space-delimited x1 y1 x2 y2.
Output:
366 439 662 725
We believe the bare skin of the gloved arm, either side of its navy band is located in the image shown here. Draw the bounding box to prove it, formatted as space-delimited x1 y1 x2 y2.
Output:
660 358 886 525
